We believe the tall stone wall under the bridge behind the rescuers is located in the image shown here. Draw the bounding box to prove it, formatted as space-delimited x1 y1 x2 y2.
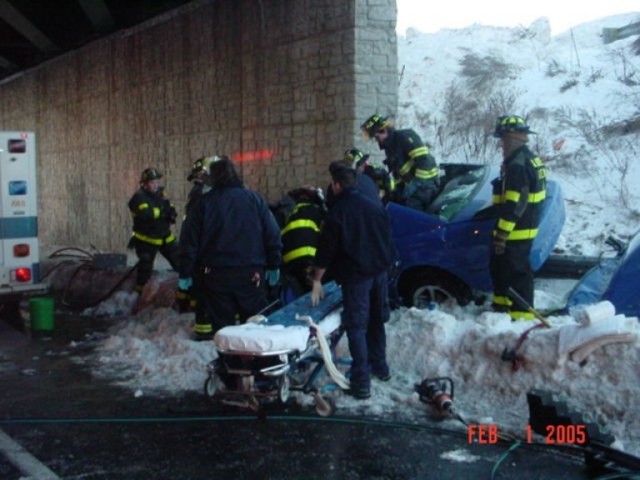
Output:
0 0 398 251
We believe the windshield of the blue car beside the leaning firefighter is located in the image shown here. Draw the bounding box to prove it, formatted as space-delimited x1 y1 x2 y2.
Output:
428 165 488 222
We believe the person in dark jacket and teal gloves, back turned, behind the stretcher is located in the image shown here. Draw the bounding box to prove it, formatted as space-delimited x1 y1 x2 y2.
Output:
178 156 282 340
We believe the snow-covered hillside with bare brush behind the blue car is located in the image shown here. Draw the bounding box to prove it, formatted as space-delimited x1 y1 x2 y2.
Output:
396 13 640 255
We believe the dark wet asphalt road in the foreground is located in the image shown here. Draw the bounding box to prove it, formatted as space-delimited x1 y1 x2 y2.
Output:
0 312 603 480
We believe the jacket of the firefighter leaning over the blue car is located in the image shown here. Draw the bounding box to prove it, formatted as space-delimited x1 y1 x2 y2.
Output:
380 129 439 183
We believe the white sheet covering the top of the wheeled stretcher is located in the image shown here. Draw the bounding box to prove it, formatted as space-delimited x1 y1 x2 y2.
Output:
213 311 340 355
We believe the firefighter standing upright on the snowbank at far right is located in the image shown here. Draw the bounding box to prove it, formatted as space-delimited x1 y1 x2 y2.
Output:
490 116 546 320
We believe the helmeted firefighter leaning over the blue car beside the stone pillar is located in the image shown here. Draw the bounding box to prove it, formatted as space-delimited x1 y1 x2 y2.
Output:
360 113 440 211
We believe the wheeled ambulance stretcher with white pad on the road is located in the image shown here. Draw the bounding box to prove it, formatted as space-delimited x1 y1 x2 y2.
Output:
204 282 349 416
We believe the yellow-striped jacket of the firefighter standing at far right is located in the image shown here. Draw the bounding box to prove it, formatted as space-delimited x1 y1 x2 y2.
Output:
493 145 547 240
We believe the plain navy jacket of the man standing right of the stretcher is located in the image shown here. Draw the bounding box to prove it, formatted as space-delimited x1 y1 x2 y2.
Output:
315 188 394 283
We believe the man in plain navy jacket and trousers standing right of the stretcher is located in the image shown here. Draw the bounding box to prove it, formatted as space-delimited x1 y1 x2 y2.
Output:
311 162 394 399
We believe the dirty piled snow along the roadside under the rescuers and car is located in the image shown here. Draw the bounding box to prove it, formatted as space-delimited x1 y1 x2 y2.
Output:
52 273 640 454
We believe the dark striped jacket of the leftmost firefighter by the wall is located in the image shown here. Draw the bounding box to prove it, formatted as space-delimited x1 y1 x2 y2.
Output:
129 188 176 244
